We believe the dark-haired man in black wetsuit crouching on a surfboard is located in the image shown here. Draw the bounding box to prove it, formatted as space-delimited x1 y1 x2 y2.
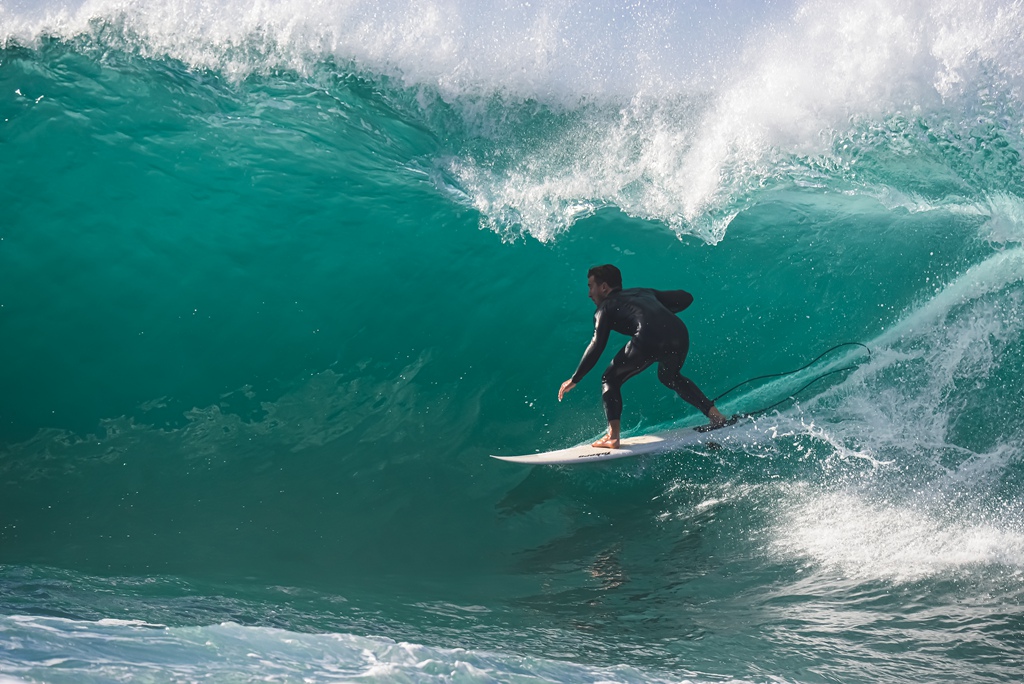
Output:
558 264 728 448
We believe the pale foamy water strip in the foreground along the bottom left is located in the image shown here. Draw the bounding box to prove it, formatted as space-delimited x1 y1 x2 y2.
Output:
0 615 729 682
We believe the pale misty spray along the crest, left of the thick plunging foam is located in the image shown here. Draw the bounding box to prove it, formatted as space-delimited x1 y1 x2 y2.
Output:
0 0 775 99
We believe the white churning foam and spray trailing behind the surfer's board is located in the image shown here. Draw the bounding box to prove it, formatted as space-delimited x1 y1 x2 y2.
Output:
774 240 1024 582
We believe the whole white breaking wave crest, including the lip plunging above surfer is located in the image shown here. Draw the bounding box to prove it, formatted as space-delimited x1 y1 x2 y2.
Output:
8 0 1024 244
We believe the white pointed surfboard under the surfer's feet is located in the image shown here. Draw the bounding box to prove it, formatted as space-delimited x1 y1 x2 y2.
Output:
490 419 756 466
